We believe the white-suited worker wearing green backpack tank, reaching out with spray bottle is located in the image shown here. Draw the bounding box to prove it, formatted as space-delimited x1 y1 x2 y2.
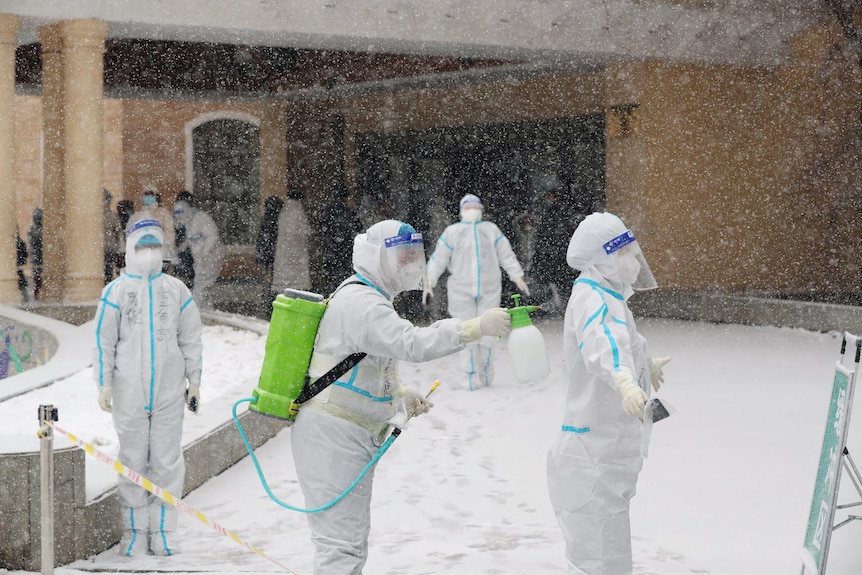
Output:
291 220 511 575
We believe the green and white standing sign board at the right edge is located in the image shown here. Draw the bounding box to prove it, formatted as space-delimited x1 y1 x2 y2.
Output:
802 362 855 575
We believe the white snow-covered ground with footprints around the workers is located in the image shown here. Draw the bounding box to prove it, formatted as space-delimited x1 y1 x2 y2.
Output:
0 319 862 575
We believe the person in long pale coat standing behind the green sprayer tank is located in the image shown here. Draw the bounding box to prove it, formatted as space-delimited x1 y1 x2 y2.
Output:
270 190 311 299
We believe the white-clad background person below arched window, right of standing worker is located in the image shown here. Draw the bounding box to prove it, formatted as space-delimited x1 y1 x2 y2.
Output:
173 192 224 310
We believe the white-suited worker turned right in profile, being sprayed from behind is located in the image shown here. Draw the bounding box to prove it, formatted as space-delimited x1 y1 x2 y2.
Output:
548 213 670 575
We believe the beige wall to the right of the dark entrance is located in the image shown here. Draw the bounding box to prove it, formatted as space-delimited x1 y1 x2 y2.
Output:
608 21 862 292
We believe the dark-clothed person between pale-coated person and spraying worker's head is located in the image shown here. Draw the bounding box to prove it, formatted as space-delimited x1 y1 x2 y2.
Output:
320 184 362 295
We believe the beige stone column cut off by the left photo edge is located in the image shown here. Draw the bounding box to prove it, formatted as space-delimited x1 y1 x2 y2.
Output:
0 14 20 303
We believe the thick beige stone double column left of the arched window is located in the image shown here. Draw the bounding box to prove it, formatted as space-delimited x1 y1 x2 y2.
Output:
40 19 108 303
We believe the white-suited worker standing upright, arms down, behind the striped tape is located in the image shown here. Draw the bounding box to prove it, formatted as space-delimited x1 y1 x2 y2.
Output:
93 220 202 556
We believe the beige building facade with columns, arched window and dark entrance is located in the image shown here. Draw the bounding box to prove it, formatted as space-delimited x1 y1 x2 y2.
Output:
0 1 862 302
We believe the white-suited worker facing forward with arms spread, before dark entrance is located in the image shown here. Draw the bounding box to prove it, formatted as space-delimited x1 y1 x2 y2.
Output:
422 194 530 390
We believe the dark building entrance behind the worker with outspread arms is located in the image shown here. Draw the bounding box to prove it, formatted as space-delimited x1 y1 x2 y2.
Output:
356 115 605 254
